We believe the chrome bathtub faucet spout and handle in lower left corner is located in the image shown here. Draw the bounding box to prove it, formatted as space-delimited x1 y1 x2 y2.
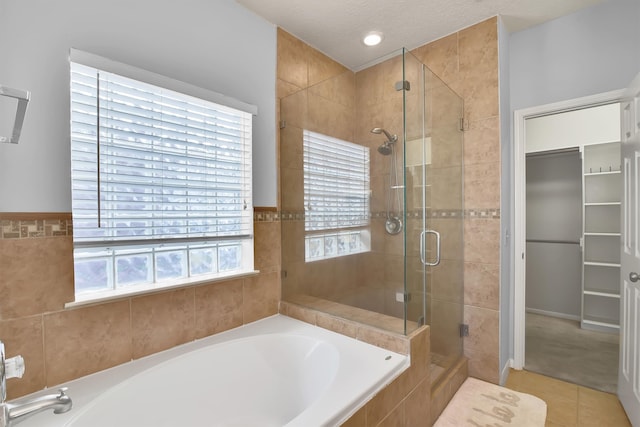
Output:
0 341 72 427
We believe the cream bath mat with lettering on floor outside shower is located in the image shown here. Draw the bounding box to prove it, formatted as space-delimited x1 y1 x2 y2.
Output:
434 378 547 427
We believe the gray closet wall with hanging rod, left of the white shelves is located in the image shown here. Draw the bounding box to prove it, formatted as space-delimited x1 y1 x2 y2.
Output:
526 150 582 318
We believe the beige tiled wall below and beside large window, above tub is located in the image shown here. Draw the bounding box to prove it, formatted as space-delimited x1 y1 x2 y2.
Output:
0 208 280 399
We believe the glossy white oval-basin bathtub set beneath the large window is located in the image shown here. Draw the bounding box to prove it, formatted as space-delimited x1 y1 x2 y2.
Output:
19 315 409 427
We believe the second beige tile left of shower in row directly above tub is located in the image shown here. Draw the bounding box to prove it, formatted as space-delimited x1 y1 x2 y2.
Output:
195 279 242 338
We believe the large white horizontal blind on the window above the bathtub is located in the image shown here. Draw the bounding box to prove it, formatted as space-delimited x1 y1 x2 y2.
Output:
71 63 253 244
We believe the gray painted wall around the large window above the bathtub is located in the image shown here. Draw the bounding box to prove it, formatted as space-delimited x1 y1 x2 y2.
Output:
0 0 277 212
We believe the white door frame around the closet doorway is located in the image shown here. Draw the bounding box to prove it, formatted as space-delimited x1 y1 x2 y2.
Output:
511 90 624 369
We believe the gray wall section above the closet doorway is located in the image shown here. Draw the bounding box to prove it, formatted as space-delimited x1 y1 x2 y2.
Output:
509 0 640 110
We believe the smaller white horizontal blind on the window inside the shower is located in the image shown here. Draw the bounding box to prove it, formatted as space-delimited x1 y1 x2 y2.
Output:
303 130 370 232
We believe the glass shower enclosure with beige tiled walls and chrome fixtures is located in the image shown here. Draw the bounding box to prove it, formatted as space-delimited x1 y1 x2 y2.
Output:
280 49 463 388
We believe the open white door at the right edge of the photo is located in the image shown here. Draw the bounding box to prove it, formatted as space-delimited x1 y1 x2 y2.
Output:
618 74 640 427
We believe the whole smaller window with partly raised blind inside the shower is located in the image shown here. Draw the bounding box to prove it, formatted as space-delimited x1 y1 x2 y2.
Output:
303 130 371 261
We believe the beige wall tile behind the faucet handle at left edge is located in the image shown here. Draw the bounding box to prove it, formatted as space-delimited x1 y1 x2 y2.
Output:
0 315 47 399
